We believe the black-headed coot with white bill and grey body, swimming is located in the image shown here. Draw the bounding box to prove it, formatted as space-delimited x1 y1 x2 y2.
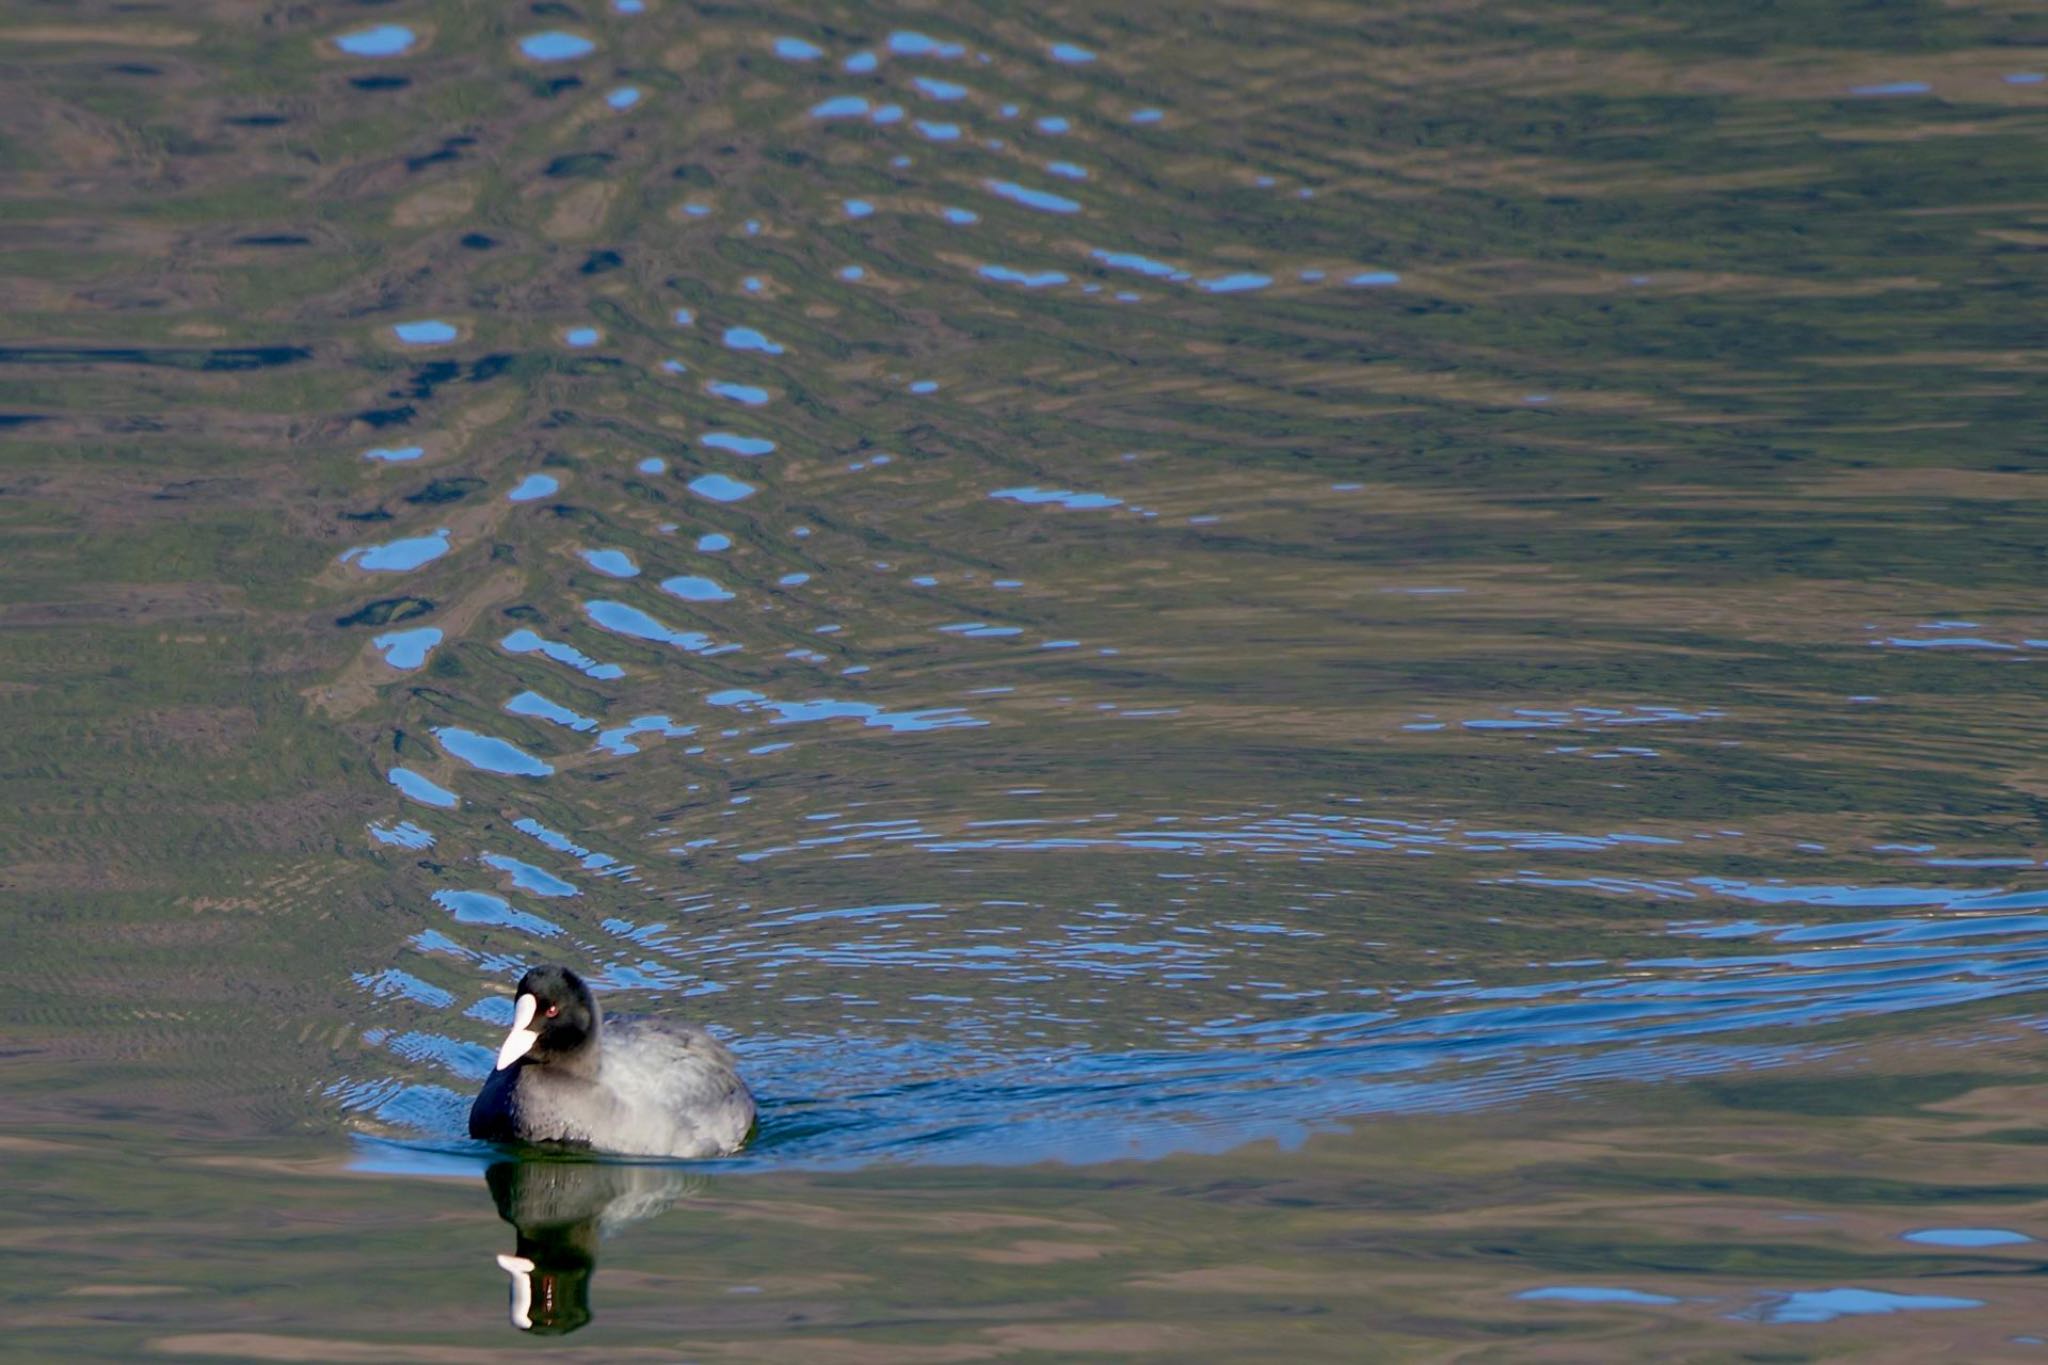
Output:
469 966 754 1156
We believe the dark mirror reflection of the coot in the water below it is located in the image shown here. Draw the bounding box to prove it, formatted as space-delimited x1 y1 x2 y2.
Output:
483 1160 702 1336
